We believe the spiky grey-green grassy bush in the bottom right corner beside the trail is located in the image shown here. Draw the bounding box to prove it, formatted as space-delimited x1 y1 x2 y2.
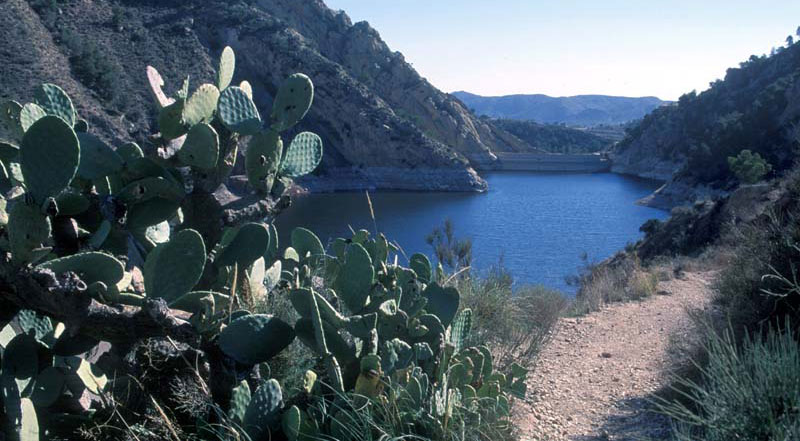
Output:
659 329 800 441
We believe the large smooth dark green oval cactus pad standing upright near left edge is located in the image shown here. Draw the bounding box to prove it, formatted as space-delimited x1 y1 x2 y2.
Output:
20 116 81 203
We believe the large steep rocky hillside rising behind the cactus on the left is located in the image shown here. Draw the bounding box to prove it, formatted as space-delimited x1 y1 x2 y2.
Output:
0 0 536 190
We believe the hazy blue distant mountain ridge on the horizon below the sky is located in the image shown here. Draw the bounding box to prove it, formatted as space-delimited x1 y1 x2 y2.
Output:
451 92 667 126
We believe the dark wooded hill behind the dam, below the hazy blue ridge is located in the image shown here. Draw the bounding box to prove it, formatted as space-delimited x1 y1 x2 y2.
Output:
492 119 612 153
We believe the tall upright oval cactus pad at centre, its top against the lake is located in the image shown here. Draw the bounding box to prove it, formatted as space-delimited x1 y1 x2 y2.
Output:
335 243 375 313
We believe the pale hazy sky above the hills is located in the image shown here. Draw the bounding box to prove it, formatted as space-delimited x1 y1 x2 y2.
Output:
325 0 800 100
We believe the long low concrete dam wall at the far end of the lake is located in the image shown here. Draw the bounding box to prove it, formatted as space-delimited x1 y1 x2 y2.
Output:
494 152 611 173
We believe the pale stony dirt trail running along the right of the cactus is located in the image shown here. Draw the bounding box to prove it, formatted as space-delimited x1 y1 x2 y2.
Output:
515 273 713 441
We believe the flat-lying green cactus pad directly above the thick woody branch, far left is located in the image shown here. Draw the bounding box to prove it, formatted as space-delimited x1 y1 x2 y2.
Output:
37 251 125 286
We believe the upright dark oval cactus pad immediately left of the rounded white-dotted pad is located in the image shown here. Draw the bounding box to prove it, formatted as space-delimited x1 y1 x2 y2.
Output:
244 130 283 193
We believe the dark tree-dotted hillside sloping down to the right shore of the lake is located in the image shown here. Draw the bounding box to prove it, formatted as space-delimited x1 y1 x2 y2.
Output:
612 40 800 207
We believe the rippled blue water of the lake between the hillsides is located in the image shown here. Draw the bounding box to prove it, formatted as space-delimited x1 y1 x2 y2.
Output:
276 172 668 293
